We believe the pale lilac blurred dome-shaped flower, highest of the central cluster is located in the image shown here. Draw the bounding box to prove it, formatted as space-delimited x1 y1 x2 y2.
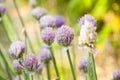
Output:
31 7 47 20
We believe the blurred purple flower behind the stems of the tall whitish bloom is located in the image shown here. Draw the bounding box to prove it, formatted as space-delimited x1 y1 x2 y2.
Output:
78 57 92 73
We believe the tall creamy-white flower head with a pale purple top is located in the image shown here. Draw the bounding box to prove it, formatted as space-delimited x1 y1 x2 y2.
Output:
79 15 97 47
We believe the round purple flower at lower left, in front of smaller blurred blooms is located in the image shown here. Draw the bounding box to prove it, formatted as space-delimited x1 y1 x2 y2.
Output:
23 54 38 71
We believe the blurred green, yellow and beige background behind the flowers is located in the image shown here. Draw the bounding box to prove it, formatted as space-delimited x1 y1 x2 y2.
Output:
0 0 120 80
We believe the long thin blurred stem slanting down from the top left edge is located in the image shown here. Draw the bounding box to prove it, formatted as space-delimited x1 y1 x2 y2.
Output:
13 0 35 53
